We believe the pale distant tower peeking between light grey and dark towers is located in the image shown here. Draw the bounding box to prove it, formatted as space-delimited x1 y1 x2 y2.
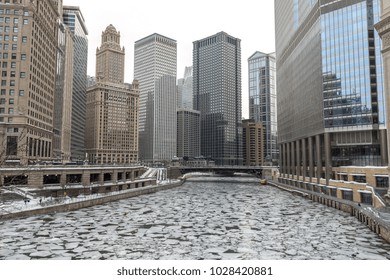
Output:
177 66 194 110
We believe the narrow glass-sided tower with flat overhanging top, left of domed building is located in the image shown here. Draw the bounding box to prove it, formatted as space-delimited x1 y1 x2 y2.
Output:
63 6 88 161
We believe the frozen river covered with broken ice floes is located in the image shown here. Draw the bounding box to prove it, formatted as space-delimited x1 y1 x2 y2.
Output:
0 179 390 260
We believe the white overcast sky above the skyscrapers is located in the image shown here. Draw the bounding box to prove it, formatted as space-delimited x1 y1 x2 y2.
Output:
64 0 275 117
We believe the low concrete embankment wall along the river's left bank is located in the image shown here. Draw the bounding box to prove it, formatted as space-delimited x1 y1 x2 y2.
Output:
0 181 183 221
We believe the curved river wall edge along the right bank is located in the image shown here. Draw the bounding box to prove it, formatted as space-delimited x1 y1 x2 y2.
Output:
268 181 390 243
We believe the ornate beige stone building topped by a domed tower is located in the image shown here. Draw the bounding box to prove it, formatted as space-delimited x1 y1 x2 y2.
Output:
86 25 139 164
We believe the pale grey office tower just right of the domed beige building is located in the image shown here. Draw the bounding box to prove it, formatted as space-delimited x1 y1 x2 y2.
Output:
134 34 177 161
